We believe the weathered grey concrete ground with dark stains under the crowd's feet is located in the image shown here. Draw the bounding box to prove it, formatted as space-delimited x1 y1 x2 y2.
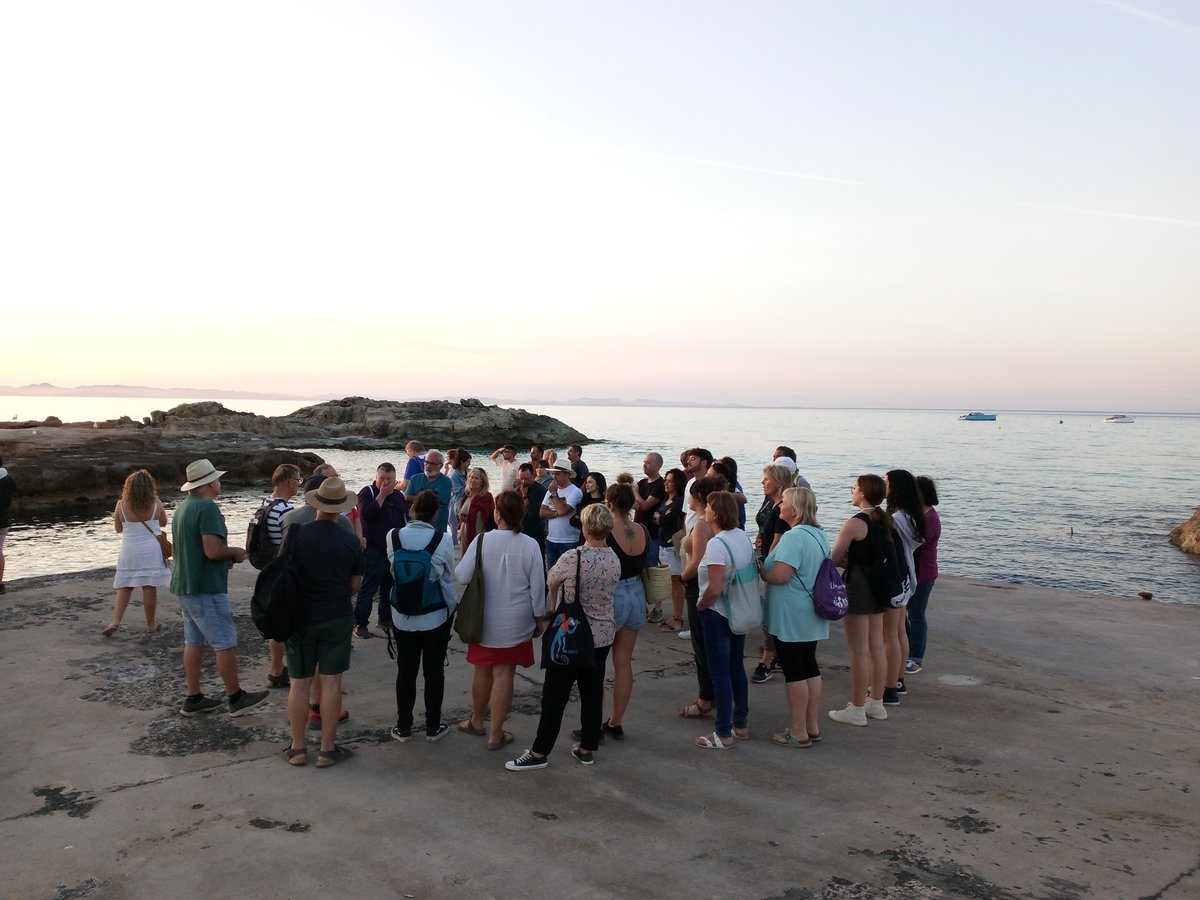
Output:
0 566 1200 900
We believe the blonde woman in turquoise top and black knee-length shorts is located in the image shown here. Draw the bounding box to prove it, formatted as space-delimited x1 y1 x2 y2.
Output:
762 487 829 748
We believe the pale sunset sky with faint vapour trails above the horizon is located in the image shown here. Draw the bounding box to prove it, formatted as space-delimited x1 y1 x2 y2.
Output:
0 0 1200 413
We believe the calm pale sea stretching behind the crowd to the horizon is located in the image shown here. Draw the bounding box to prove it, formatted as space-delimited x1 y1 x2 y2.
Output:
0 396 1200 605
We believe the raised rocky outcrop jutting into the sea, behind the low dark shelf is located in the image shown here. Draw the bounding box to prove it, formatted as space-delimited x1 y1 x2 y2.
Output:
151 397 587 450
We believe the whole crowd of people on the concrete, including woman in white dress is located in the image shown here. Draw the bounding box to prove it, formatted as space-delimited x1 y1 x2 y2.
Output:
102 442 941 772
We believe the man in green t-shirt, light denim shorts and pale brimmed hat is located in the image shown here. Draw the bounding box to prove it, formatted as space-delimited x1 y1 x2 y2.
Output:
170 460 266 716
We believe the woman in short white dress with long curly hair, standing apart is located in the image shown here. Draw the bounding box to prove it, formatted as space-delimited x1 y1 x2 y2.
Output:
101 469 170 637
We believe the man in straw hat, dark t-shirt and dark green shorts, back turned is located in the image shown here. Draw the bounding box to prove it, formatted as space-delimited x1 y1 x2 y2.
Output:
283 476 362 768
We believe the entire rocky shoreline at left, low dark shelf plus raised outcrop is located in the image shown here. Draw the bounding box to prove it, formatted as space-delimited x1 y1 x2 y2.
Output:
0 397 588 514
